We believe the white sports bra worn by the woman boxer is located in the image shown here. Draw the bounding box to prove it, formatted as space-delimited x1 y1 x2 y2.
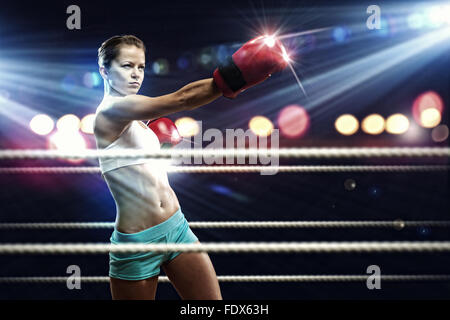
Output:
99 120 160 174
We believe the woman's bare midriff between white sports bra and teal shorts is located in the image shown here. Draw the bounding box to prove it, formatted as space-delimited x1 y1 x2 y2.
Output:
104 163 180 233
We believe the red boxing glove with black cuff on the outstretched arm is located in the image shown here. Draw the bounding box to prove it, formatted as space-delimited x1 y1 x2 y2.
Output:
213 36 289 98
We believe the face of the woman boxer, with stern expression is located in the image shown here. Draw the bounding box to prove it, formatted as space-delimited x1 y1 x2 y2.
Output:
106 45 145 96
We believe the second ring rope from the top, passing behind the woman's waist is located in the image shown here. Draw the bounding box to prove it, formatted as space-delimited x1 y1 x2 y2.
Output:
0 165 450 174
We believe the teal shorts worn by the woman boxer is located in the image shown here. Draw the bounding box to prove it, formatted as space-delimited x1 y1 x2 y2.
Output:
109 209 198 280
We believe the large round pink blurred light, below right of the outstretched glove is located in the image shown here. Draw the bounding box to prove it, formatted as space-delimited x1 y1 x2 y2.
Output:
277 105 310 138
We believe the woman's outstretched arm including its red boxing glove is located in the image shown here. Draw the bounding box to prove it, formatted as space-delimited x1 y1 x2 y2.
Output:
103 36 288 122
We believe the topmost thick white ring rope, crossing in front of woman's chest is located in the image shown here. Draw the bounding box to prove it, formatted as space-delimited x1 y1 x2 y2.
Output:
0 147 450 159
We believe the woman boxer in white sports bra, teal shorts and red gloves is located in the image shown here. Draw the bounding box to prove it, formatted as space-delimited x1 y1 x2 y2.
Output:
94 35 286 300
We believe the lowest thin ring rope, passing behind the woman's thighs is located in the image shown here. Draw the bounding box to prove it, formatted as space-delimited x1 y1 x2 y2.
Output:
0 274 450 283
